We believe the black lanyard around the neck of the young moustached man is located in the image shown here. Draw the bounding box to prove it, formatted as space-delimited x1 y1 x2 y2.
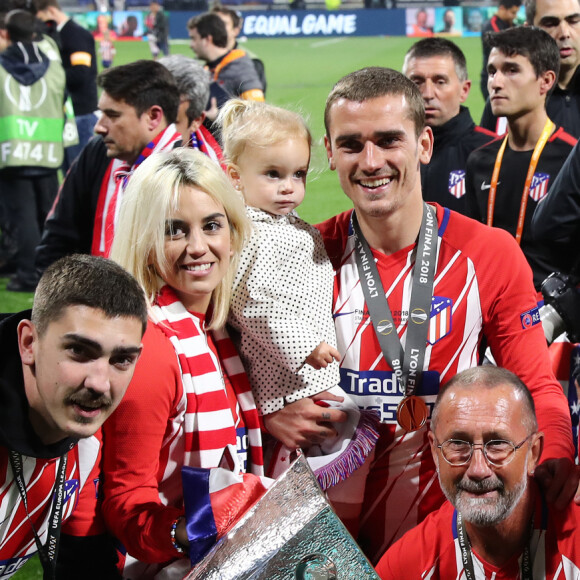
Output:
10 451 67 580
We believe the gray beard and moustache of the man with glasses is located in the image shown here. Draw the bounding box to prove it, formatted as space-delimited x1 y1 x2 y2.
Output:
439 458 528 527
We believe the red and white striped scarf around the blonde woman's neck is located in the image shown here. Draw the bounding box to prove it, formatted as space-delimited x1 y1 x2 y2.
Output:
152 286 264 475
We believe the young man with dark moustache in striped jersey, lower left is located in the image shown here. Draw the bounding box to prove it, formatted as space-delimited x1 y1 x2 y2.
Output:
0 255 147 579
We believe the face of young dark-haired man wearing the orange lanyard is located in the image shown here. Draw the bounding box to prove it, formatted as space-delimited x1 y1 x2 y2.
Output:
487 48 555 119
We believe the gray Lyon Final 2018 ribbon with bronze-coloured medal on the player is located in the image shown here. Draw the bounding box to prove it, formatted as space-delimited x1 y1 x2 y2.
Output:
351 203 438 431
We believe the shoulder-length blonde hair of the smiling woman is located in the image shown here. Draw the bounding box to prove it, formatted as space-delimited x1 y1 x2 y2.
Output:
111 147 250 328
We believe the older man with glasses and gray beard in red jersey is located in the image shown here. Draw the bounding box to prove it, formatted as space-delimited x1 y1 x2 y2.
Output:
377 366 580 580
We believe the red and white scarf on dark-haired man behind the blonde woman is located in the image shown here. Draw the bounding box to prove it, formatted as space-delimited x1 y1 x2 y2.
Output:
91 124 181 258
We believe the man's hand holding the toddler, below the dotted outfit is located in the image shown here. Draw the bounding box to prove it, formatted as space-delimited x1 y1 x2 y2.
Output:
264 391 347 449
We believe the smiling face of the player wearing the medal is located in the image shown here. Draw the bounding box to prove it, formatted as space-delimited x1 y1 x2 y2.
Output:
325 95 433 218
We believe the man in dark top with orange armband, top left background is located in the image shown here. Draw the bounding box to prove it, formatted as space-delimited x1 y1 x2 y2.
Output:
36 0 97 172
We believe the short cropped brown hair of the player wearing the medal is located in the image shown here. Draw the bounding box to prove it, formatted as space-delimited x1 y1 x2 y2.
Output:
324 66 425 138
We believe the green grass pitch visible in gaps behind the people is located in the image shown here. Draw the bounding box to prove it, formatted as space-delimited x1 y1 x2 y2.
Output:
7 32 484 580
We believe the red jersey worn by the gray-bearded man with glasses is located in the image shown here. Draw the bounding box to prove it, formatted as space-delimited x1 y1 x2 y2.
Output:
377 486 580 580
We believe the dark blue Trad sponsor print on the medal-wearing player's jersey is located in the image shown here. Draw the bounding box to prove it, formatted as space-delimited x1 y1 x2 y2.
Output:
340 368 439 425
